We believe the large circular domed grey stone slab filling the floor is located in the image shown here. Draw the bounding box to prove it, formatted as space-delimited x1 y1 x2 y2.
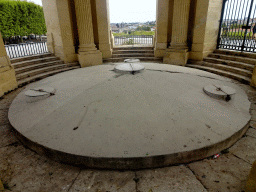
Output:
8 64 250 169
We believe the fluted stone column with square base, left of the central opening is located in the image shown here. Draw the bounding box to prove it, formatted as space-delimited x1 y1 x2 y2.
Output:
75 0 102 67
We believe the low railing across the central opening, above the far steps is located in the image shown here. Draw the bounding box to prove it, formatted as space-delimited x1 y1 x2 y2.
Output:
114 35 153 46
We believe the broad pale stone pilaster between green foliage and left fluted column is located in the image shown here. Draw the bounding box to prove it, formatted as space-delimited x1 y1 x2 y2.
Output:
42 0 77 63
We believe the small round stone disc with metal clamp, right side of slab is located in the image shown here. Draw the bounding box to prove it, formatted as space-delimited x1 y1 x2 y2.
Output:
203 85 236 102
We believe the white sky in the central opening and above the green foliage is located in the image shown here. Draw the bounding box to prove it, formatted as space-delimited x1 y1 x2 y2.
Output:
28 0 156 23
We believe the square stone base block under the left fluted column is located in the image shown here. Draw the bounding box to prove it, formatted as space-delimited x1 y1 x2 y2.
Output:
78 51 102 67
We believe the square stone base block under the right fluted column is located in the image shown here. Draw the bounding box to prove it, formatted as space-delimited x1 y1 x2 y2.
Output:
163 48 189 66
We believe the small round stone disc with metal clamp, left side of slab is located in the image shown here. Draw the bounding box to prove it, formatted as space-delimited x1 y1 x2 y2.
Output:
25 87 56 103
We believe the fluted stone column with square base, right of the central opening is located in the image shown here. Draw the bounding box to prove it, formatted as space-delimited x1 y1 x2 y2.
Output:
163 0 190 65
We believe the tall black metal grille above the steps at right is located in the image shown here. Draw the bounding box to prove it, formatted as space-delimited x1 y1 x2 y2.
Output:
217 0 256 52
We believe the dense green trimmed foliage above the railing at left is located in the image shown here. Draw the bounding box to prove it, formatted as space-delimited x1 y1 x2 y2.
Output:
0 0 46 38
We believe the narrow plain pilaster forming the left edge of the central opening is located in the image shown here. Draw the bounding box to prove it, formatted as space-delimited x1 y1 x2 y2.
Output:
96 0 112 58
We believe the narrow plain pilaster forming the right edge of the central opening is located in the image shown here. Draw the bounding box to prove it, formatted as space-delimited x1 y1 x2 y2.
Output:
155 0 169 57
